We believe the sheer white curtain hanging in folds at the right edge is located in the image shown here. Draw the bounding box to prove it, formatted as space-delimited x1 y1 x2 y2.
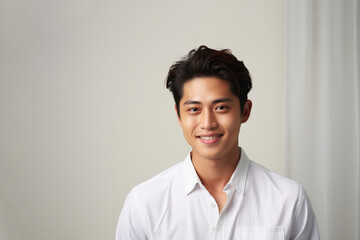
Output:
284 0 360 240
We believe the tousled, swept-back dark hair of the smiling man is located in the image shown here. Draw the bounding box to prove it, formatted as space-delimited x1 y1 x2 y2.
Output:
166 46 252 117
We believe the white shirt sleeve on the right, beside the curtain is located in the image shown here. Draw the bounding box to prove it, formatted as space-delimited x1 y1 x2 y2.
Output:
290 186 320 240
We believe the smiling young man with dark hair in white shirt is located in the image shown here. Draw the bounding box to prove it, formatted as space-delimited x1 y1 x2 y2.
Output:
116 46 319 240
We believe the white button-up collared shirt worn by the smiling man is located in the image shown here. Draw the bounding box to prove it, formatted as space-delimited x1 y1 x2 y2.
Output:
116 150 320 240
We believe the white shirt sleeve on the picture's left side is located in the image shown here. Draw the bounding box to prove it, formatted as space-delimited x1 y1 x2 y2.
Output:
115 190 147 240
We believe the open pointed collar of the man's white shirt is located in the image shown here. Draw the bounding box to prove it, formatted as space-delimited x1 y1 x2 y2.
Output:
184 148 250 195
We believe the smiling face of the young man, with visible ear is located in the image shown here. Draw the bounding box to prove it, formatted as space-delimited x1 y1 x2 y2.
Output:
178 77 251 160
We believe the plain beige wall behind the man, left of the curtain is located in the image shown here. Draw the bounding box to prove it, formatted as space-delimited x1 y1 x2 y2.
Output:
0 0 285 240
